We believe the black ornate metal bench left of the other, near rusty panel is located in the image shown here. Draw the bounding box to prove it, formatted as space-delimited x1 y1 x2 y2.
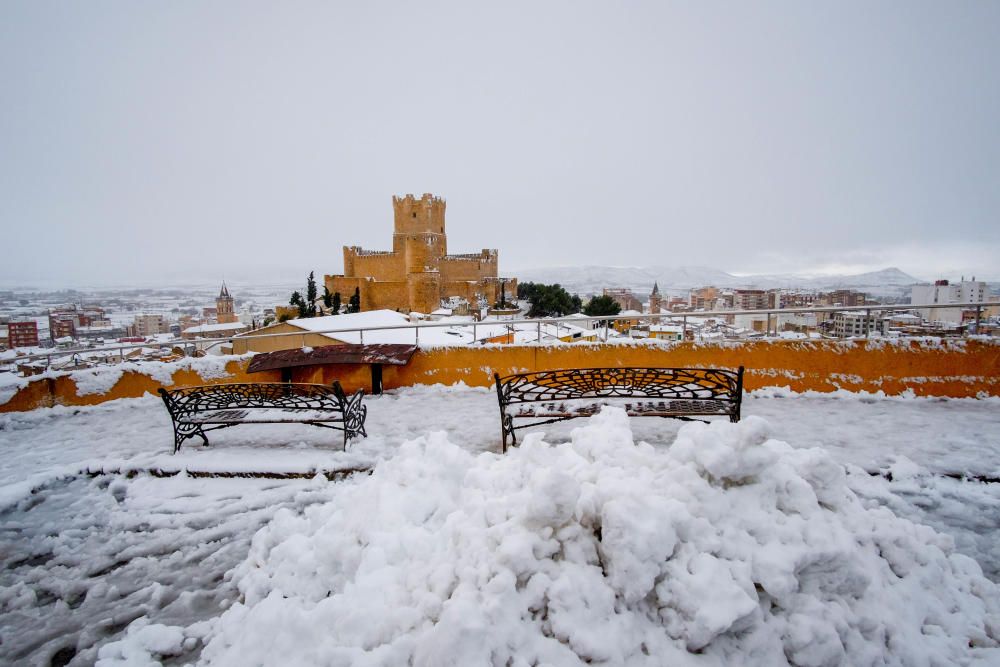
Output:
159 381 368 453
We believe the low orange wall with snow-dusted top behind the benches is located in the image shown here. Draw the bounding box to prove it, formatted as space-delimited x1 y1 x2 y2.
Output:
0 340 1000 412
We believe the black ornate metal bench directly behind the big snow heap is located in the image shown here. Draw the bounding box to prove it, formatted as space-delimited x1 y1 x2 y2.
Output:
493 366 743 451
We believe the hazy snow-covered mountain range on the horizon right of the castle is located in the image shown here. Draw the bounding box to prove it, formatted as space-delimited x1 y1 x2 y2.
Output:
517 266 922 296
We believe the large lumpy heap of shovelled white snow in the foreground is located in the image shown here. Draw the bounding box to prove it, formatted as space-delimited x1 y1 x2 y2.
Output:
117 408 1000 665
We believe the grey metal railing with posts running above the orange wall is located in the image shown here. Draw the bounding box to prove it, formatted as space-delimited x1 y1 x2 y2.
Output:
6 302 1000 374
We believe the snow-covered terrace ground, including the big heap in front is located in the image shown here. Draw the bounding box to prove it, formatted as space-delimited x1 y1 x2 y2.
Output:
0 387 1000 665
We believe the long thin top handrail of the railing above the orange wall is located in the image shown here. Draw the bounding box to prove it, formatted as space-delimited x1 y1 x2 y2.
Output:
0 301 1000 363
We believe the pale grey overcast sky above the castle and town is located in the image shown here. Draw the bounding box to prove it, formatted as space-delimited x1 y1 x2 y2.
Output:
0 0 1000 286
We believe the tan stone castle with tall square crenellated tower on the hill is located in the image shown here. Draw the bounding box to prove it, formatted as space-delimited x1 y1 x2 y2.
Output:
323 194 517 313
